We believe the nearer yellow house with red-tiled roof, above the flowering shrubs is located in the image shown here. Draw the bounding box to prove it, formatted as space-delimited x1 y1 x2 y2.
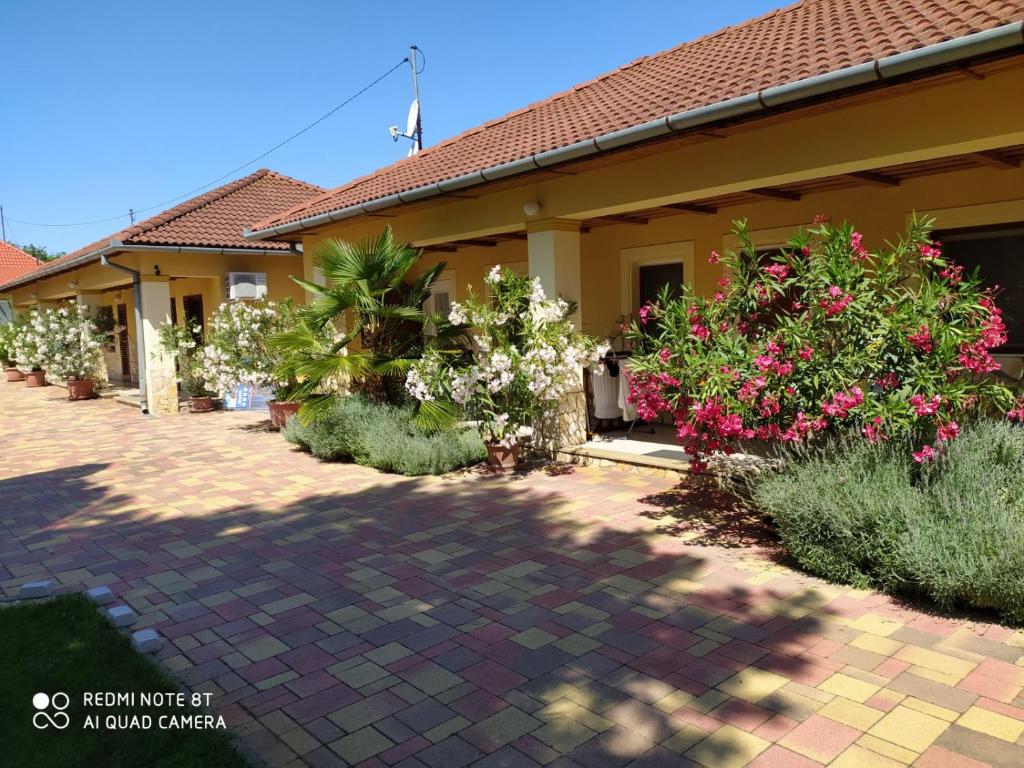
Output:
246 0 1024 450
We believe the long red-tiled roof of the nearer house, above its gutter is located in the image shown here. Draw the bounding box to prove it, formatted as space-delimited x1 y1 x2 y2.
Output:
249 0 1024 238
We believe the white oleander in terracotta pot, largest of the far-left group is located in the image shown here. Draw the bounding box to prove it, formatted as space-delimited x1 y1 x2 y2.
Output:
45 304 103 400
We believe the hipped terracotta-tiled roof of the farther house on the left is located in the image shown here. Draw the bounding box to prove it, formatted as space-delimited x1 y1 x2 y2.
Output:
0 168 324 289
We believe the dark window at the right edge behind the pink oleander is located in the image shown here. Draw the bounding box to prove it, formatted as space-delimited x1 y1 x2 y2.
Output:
933 223 1024 353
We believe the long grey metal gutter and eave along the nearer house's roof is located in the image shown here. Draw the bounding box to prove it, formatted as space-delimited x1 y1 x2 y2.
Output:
243 22 1024 241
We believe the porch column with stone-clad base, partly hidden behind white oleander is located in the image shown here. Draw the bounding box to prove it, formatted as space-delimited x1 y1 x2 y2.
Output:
526 219 587 450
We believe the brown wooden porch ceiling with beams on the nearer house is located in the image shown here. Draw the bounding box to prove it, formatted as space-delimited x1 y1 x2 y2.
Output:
423 144 1024 253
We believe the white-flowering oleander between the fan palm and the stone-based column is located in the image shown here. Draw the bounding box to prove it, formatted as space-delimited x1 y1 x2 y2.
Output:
406 266 595 447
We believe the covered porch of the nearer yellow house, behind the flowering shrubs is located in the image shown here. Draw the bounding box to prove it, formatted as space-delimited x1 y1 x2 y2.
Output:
403 143 1024 472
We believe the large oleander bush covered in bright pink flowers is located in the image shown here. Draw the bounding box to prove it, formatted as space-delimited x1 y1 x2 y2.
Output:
630 217 1024 469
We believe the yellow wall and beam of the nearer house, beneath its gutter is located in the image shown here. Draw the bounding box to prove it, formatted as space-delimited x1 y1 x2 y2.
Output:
290 57 1024 336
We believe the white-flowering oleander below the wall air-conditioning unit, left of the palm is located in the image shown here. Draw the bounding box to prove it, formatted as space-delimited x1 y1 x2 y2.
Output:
200 299 295 399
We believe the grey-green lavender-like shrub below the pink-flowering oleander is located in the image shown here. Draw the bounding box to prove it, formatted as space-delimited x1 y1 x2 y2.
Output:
751 421 1024 623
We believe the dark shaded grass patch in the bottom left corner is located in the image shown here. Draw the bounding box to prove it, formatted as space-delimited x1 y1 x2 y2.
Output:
0 595 248 768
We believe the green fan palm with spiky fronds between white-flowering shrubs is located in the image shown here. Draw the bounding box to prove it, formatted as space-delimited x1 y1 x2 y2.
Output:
271 226 466 426
